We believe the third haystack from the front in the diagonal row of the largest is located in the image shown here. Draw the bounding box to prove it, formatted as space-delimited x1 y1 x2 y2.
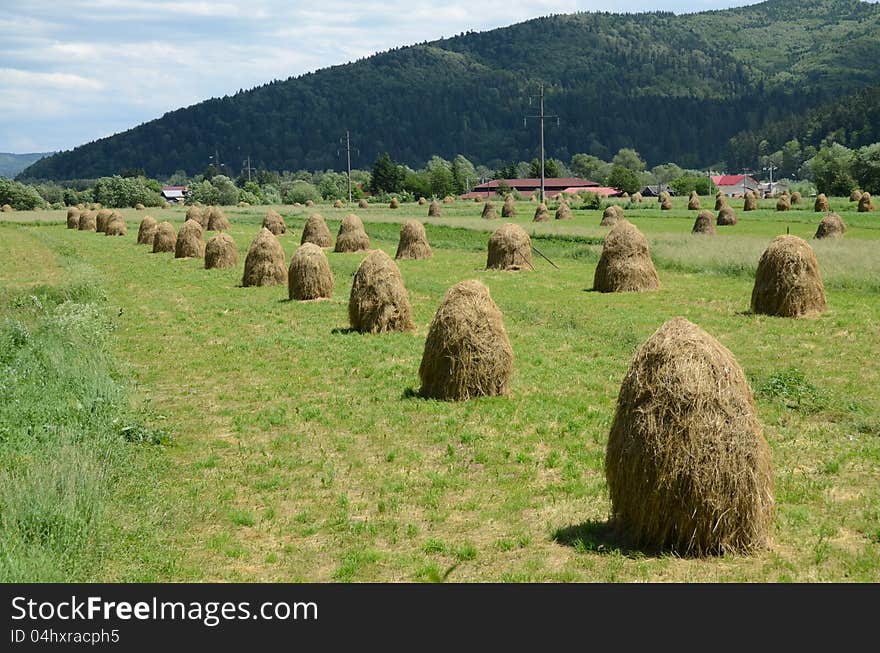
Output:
348 249 415 333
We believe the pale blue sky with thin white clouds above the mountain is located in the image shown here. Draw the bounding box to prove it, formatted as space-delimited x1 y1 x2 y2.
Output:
0 0 768 153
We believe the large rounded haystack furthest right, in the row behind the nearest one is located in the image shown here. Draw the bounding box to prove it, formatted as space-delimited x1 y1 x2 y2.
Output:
752 235 825 317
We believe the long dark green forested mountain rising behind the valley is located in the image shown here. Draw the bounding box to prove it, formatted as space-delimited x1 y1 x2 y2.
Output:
21 0 880 179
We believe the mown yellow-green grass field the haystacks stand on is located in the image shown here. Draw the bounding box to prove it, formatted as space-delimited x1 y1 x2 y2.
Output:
0 199 880 582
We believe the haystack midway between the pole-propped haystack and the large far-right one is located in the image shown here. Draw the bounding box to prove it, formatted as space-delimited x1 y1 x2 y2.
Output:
593 220 660 292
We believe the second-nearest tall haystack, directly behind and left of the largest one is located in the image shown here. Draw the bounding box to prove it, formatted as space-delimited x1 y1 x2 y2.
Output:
419 280 513 401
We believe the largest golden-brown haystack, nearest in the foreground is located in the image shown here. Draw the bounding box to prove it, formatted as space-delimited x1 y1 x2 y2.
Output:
605 317 774 556
